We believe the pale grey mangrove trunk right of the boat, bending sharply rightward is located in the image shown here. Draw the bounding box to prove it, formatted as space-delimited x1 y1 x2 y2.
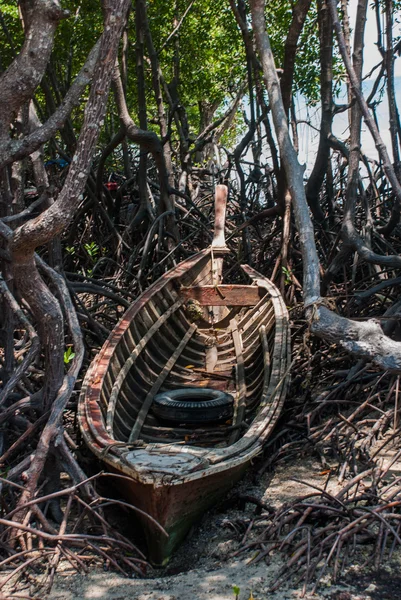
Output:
251 0 401 372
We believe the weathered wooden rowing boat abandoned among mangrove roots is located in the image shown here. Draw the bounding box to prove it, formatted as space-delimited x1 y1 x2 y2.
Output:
79 186 290 564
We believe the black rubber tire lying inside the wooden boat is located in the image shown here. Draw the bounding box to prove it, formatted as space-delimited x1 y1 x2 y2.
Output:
152 388 234 424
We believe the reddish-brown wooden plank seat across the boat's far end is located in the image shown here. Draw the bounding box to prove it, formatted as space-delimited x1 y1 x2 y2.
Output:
180 285 261 306
